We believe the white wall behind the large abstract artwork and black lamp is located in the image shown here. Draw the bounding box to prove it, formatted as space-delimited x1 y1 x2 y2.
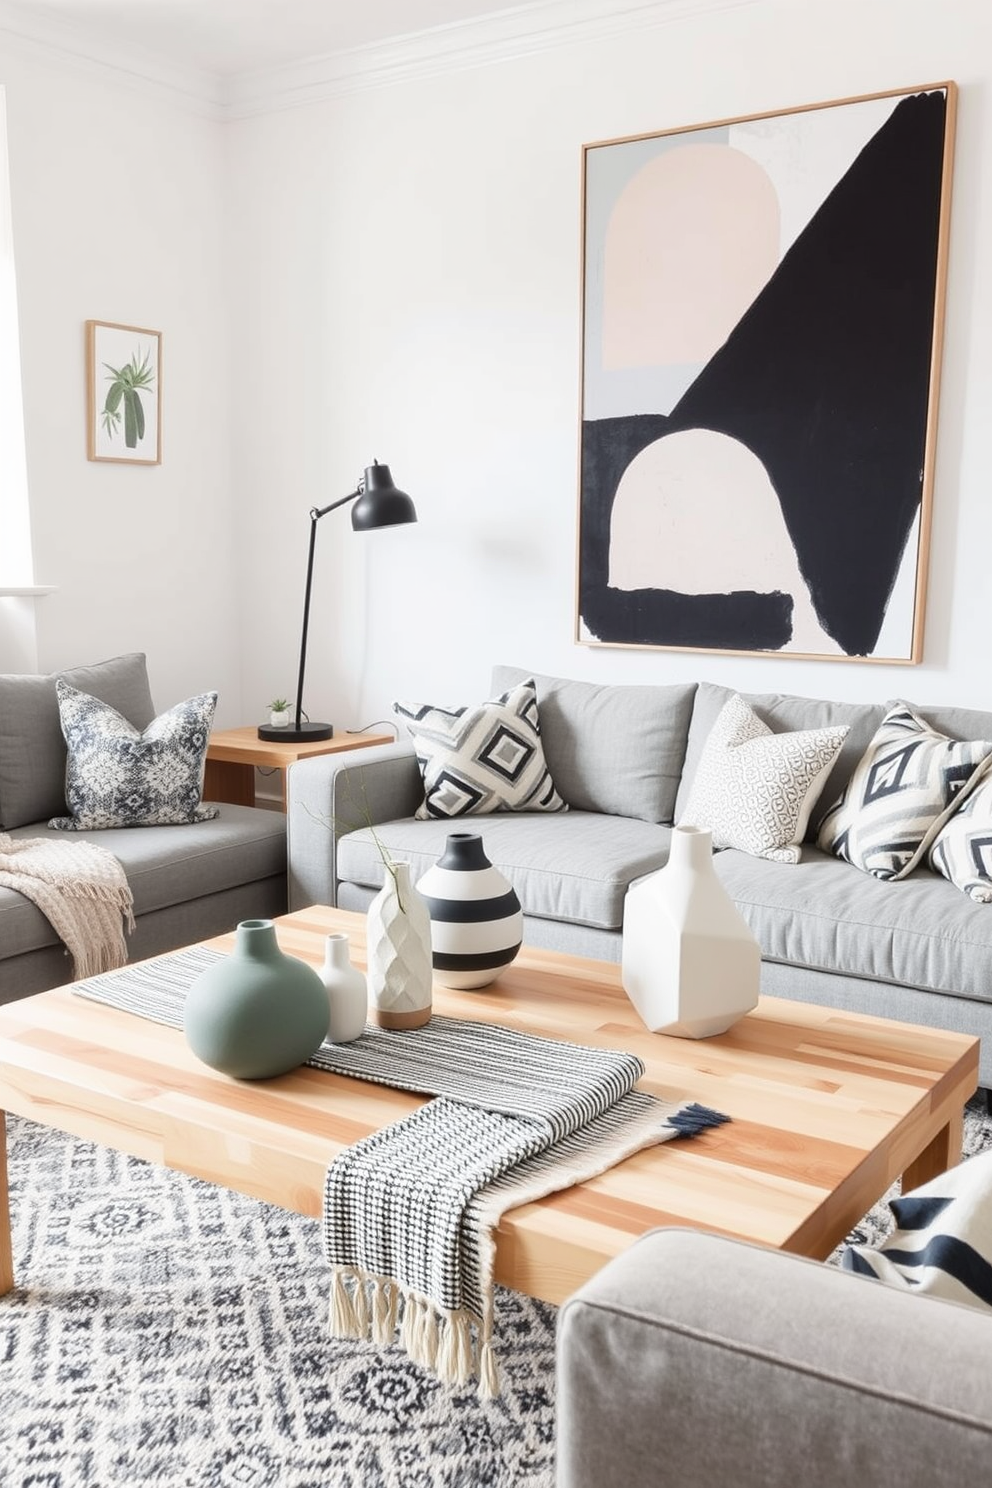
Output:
229 0 992 725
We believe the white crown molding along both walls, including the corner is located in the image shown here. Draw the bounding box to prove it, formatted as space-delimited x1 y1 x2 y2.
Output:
0 0 761 121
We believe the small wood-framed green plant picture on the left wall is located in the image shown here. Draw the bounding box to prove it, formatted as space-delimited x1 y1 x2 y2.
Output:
86 320 162 464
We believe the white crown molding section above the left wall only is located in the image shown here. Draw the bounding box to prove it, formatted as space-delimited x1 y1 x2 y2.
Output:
0 0 225 119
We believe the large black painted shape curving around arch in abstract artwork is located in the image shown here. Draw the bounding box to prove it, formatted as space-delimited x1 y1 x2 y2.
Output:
580 89 946 656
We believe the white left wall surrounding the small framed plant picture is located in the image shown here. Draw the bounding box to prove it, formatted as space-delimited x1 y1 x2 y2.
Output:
0 34 242 723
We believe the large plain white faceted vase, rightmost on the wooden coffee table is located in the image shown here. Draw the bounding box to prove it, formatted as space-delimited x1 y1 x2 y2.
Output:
620 826 761 1039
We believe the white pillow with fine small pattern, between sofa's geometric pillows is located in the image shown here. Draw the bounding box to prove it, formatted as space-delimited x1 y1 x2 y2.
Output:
680 693 848 863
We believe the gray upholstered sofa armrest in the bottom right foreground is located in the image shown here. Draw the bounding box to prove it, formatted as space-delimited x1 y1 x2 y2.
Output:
558 1229 992 1488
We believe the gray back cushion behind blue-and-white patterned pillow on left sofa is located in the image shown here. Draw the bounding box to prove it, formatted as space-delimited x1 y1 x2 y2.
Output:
0 652 155 832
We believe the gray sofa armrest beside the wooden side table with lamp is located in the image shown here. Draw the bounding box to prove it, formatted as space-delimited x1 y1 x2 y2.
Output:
286 740 424 911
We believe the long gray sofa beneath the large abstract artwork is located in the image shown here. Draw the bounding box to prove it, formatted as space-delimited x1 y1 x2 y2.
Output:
289 667 992 1089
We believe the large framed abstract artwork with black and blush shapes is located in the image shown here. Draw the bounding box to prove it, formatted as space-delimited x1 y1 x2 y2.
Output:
577 83 955 662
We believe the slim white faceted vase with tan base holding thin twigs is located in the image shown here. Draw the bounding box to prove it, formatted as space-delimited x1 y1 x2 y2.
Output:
366 863 433 1028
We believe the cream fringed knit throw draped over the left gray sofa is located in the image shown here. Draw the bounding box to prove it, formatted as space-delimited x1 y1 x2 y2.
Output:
0 832 134 981
